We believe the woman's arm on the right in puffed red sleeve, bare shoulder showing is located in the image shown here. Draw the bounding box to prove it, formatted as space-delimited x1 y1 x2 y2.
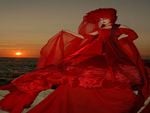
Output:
118 26 145 78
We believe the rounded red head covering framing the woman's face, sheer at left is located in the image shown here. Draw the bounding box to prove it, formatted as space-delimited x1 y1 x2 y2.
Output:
78 8 117 35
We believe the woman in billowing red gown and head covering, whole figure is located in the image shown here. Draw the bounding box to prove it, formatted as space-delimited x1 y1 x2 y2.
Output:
0 8 149 113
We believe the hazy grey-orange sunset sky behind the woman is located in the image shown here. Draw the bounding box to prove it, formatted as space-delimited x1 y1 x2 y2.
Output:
0 0 150 58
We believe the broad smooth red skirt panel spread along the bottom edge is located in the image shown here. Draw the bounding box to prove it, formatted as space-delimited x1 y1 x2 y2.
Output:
28 85 135 113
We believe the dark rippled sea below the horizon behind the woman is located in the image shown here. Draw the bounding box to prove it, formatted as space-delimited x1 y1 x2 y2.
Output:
0 57 150 85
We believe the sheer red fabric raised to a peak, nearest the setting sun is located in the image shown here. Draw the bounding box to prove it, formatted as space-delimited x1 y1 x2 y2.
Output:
37 31 82 68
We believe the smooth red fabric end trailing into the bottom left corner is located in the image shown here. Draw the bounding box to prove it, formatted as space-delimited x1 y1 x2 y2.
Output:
0 90 37 113
